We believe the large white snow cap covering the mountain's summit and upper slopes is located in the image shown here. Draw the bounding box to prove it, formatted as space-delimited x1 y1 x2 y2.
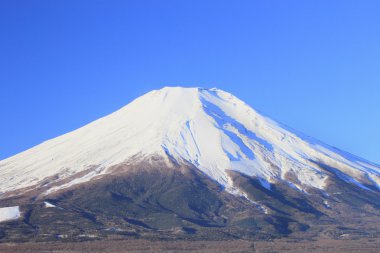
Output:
0 87 380 195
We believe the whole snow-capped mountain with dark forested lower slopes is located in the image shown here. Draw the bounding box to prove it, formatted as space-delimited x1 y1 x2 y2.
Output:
0 87 380 241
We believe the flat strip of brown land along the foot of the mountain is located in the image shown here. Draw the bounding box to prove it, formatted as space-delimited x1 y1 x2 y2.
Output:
0 239 380 253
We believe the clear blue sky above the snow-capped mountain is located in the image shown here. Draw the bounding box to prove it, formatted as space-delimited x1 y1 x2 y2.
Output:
0 0 380 163
